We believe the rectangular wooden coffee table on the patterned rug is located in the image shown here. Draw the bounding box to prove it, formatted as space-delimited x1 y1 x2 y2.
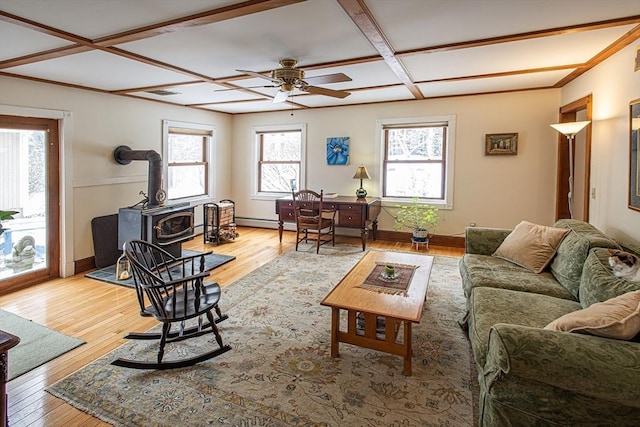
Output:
321 250 433 375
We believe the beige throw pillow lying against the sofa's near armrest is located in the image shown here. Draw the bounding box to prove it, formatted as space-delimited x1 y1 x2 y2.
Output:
544 291 640 340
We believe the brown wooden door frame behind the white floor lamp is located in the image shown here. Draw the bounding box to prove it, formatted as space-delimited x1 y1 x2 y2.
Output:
556 95 593 222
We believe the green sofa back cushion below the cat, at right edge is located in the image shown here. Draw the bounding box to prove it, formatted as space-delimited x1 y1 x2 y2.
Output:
579 248 640 308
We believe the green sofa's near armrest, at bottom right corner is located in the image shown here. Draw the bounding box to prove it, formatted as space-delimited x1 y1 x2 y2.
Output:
483 323 640 408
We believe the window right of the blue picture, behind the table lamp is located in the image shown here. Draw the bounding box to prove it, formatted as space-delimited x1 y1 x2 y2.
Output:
379 117 454 205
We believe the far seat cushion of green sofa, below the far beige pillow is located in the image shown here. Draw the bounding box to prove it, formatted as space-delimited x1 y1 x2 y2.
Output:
460 254 574 299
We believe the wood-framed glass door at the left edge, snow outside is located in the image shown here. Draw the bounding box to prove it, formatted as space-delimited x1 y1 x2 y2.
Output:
0 115 60 293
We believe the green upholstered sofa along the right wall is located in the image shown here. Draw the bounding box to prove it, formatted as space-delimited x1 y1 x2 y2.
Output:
460 220 640 427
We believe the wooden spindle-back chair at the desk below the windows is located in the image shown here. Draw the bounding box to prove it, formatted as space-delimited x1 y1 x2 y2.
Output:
292 190 336 253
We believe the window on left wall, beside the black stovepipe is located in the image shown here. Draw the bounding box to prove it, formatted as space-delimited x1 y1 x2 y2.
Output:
162 120 214 200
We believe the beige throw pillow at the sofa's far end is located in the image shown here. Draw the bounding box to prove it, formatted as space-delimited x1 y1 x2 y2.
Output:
493 221 570 273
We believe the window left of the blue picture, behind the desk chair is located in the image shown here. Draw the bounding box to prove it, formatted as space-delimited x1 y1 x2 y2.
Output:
254 125 305 195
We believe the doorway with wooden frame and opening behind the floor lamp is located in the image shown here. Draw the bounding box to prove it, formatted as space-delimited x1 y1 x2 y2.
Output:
556 95 593 222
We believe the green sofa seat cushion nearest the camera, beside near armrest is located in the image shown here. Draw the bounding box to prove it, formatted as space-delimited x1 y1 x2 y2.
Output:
469 288 582 369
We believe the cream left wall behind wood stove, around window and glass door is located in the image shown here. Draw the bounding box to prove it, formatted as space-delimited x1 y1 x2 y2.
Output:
0 77 232 271
